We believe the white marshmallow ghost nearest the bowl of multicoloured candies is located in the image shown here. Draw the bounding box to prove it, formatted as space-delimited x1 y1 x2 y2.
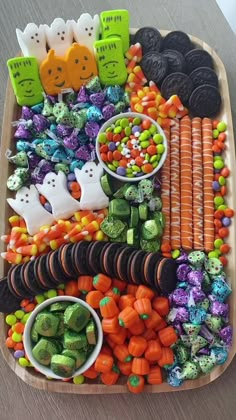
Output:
75 162 109 210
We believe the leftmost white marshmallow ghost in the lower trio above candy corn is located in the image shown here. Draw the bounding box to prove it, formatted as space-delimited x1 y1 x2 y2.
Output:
7 185 55 235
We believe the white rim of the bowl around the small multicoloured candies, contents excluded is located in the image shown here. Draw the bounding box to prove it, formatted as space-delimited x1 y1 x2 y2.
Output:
96 112 167 182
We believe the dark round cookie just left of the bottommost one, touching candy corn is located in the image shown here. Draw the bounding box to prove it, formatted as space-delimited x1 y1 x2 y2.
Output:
161 72 193 105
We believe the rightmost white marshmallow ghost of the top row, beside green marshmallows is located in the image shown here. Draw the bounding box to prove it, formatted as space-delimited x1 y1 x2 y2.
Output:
71 13 100 53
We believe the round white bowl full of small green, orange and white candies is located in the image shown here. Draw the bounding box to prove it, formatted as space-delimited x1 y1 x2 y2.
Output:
96 112 167 182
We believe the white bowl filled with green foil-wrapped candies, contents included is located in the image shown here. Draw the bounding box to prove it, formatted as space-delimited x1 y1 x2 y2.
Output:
23 296 103 379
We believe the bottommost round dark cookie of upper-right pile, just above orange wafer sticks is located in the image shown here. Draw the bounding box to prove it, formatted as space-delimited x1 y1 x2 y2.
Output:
189 85 221 118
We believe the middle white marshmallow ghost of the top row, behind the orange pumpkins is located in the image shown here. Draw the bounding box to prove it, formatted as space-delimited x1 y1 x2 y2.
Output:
44 18 73 57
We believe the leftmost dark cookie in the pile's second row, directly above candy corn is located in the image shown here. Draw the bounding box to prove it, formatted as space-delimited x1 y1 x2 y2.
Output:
140 51 168 85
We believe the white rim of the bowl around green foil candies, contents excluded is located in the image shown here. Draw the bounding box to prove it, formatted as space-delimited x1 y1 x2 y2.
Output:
23 296 103 379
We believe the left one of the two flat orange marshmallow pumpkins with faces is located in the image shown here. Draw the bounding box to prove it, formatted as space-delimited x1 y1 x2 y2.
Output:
39 50 71 95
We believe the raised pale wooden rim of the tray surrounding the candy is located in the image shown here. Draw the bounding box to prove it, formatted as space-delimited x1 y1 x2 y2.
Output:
0 28 236 394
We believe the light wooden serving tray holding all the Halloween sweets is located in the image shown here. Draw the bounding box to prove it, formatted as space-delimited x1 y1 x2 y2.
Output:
0 29 236 394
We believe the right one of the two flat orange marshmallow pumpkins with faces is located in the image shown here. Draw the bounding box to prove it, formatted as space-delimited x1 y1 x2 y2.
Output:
65 42 98 90
